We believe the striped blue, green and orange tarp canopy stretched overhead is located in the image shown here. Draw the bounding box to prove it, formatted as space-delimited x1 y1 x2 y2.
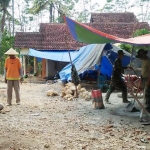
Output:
64 16 150 45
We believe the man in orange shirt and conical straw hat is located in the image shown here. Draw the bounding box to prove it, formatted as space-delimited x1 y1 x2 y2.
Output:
4 48 23 106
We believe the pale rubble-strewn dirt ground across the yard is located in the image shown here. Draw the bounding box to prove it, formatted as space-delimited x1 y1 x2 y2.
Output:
0 83 150 150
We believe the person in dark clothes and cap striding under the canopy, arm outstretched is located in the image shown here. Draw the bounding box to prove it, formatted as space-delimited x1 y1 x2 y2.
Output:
105 50 131 104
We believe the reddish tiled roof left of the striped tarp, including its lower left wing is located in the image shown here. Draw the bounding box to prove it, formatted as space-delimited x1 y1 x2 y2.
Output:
15 23 84 50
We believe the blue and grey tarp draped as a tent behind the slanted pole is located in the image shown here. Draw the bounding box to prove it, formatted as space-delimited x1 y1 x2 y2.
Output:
59 43 131 81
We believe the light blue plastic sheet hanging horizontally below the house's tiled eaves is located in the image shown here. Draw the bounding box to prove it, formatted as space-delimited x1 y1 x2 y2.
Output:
28 48 78 62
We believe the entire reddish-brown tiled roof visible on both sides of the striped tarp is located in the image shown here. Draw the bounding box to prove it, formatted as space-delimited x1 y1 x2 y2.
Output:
15 13 150 50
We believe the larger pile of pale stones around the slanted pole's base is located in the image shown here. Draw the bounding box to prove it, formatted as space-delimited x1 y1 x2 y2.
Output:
61 82 91 101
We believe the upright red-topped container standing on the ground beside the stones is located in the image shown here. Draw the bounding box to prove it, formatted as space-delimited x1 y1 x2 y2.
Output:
92 90 105 109
